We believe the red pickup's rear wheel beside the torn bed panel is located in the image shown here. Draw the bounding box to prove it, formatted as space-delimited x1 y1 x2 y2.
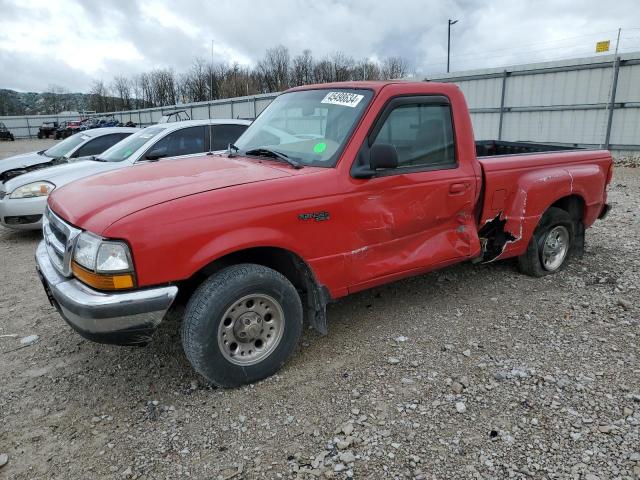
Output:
518 207 576 277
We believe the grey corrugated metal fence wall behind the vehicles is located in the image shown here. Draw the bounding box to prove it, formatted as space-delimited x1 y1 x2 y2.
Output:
0 52 640 151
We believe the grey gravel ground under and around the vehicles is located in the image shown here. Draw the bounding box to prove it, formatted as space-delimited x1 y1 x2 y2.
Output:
0 141 640 480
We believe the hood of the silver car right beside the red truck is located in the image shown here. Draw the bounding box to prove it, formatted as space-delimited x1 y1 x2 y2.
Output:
4 158 122 192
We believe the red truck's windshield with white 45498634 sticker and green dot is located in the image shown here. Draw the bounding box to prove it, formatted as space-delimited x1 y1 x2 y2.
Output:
235 88 373 167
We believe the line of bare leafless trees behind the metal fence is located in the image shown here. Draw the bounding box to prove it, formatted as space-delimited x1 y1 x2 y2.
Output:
87 45 409 112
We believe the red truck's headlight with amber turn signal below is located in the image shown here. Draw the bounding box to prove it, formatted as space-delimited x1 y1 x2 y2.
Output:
71 232 135 290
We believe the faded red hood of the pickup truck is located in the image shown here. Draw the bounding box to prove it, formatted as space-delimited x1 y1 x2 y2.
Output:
49 155 304 234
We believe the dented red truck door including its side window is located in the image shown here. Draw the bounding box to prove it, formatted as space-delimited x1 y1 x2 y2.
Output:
347 95 478 291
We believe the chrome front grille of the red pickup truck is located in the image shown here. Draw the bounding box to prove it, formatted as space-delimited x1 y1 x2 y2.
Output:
42 207 80 277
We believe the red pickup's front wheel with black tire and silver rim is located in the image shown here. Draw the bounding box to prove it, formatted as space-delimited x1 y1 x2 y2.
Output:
182 264 303 387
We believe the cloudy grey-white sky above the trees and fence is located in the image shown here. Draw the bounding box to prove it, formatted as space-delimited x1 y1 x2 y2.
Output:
0 0 640 92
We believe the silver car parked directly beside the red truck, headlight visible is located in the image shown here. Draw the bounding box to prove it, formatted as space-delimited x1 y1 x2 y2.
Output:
0 120 251 230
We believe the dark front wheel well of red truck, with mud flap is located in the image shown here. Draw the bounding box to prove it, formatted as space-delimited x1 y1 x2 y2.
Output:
180 247 331 334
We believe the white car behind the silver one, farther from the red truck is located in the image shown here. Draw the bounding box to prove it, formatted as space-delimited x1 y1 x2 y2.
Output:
0 127 139 185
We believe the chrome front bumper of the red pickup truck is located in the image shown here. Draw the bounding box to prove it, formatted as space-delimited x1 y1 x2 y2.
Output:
36 241 178 345
